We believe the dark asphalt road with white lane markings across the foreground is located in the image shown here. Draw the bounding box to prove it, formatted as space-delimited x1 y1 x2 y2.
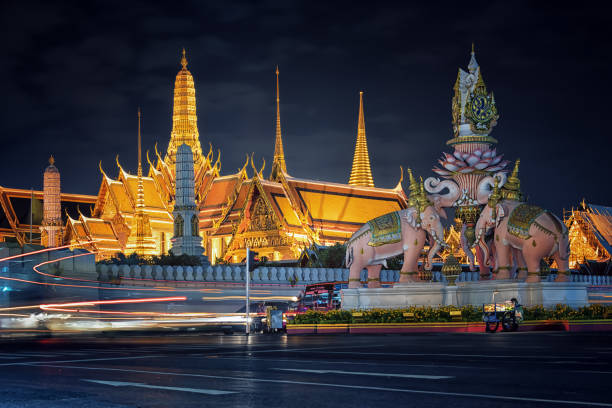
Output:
0 332 612 408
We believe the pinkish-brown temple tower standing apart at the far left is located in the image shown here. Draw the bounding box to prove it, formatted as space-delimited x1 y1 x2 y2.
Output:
41 156 62 247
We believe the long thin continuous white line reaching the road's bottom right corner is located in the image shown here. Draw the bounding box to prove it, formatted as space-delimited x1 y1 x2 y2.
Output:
35 364 612 407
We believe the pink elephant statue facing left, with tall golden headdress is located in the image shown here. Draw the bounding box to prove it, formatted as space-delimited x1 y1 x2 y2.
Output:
474 171 570 282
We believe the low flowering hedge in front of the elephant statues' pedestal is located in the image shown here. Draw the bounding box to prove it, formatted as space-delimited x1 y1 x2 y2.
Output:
289 304 612 324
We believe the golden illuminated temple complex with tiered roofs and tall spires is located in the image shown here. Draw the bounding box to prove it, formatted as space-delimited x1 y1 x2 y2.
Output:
0 50 407 263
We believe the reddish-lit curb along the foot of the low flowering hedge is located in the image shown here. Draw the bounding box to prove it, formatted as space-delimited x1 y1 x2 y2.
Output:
287 320 612 335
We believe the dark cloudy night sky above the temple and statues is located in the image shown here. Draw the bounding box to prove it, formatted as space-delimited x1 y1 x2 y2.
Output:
0 0 612 215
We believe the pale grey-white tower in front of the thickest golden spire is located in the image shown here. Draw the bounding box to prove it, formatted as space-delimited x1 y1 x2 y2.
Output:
172 143 204 256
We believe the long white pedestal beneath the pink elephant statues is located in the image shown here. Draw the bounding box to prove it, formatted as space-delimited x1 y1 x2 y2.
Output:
342 280 589 310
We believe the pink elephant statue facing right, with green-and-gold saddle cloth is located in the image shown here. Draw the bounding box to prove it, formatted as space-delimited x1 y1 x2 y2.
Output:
345 177 447 288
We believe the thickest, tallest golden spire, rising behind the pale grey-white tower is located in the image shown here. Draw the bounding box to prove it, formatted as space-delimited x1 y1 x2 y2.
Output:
164 49 204 171
